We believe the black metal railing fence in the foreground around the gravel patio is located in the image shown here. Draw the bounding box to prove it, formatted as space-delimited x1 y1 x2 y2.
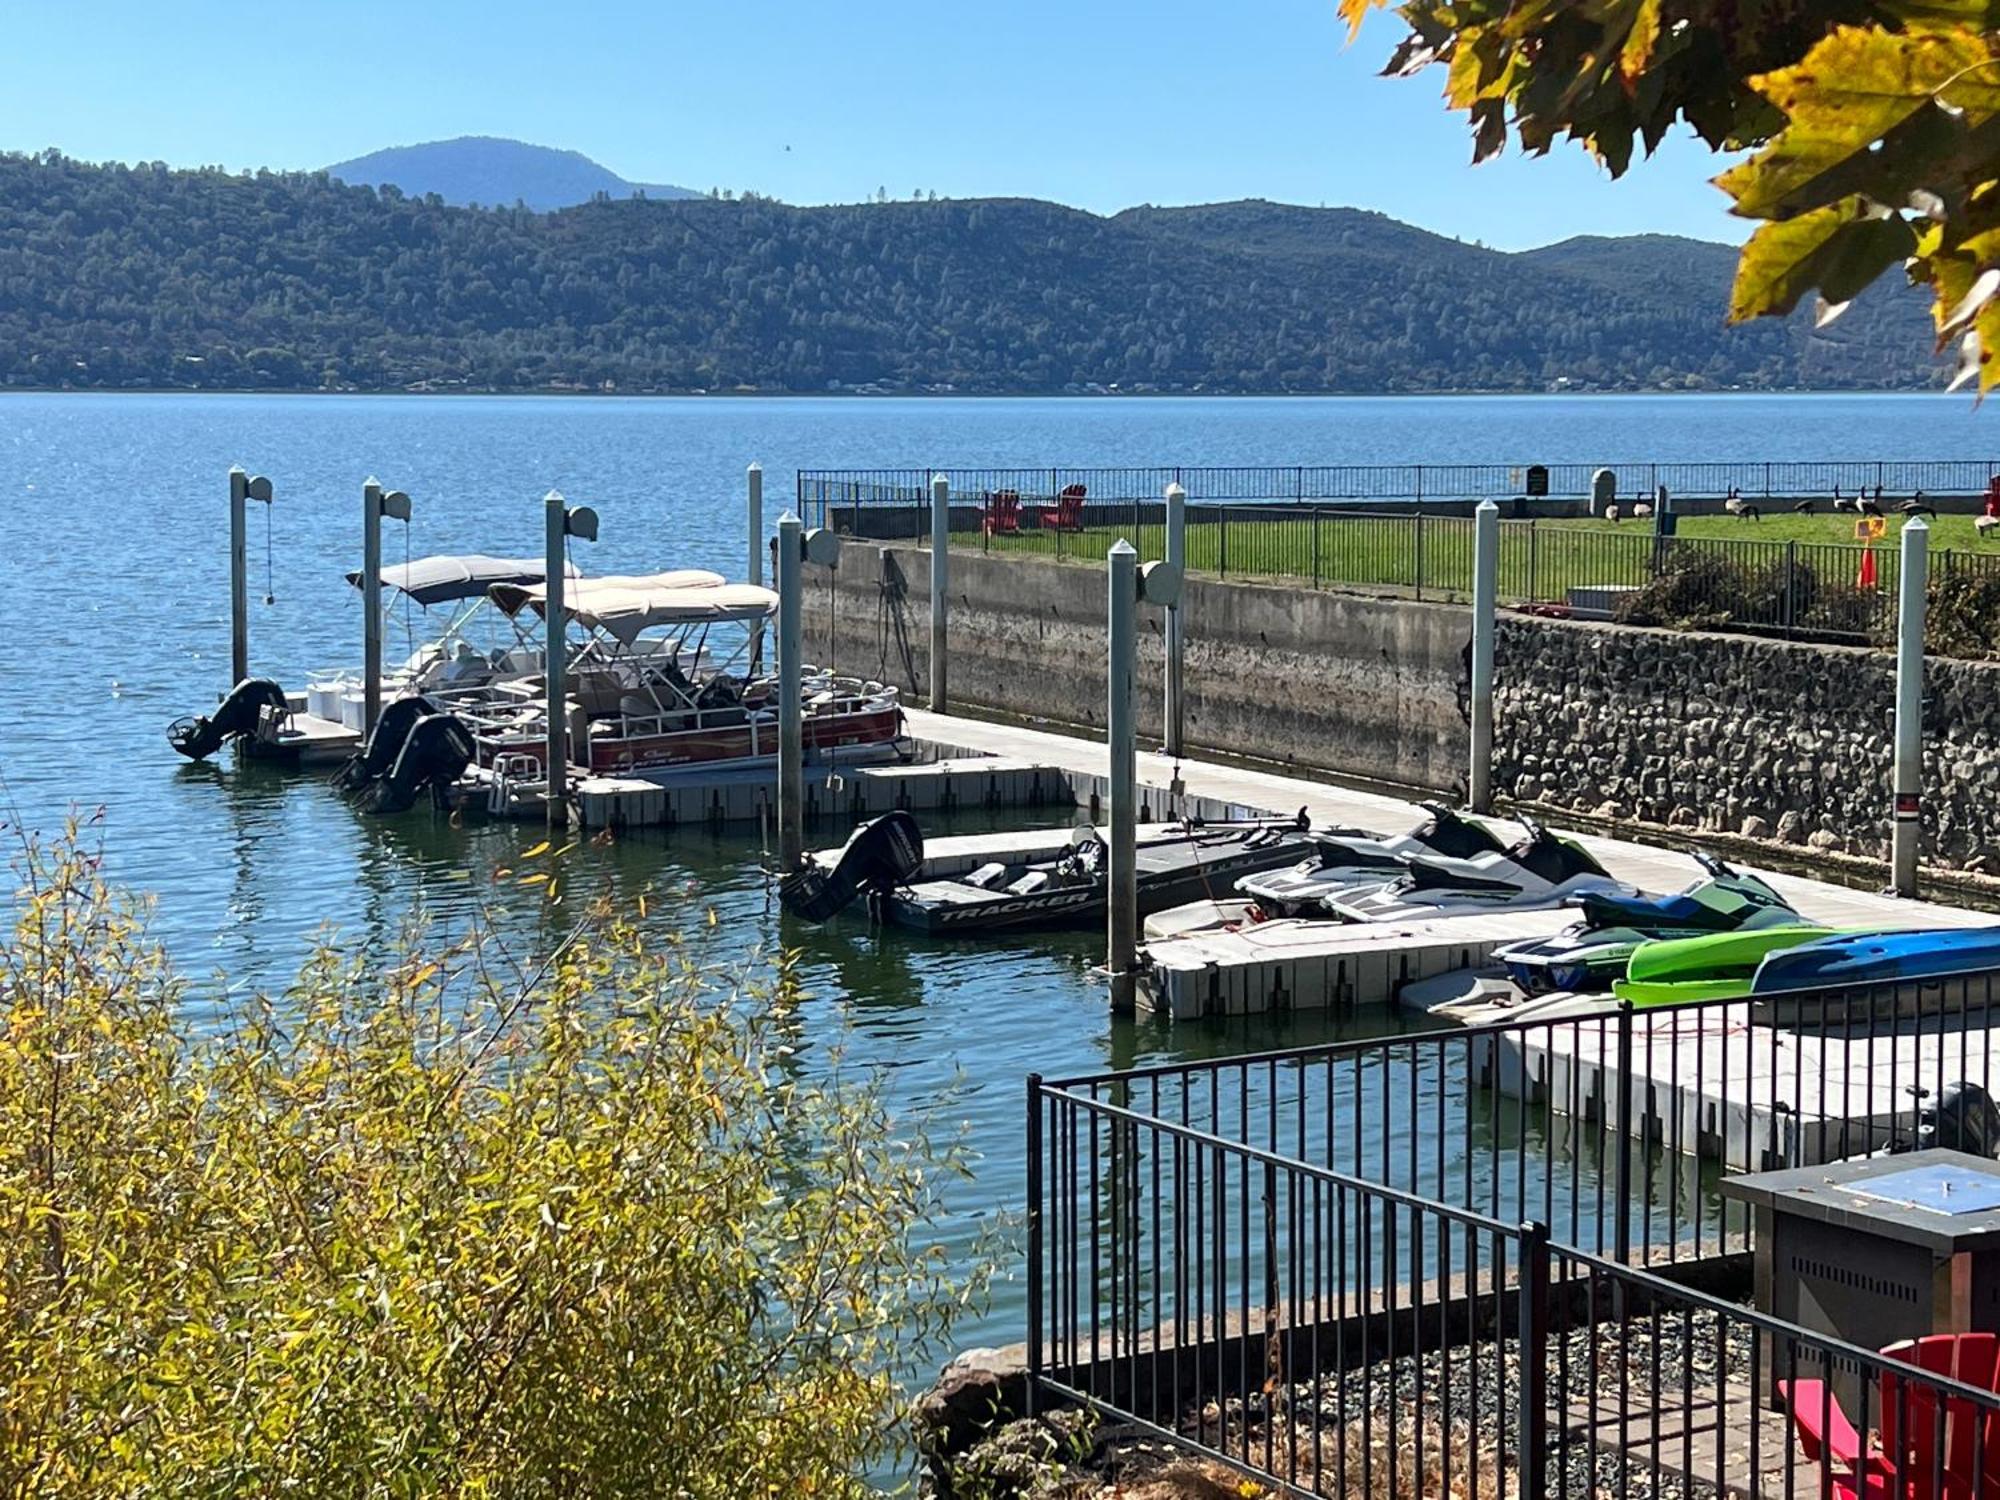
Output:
1028 974 2000 1500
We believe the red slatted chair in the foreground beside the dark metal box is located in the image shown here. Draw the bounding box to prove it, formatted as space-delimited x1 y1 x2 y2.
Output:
1778 1334 2000 1500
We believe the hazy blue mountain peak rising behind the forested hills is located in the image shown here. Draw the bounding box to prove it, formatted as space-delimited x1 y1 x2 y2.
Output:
326 136 702 212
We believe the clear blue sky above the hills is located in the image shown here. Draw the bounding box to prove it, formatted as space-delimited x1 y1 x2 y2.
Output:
0 0 1742 248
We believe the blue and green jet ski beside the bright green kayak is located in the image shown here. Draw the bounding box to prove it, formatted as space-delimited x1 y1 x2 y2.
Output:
1494 854 1800 994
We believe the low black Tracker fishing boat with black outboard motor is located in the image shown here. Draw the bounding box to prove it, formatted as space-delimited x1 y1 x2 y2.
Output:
780 814 1308 934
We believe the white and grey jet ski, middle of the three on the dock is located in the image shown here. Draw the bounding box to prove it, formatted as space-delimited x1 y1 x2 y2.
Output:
1320 820 1644 922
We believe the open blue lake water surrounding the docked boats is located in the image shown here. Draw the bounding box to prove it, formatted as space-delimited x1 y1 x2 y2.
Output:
0 394 2000 1392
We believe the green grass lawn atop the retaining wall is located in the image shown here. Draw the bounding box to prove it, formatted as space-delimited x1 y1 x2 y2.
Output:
954 506 2000 600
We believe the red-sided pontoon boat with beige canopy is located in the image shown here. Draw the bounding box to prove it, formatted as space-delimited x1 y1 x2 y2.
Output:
452 574 902 786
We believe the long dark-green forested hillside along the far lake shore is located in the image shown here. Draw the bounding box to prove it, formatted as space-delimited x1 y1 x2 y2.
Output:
0 154 1936 392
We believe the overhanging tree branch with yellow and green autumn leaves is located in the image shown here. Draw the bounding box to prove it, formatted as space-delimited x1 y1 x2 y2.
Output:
1340 0 2000 392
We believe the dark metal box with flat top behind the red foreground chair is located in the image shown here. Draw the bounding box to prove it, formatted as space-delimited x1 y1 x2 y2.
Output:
1722 1150 2000 1412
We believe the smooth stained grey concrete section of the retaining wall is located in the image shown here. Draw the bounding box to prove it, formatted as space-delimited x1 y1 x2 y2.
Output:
808 542 1470 792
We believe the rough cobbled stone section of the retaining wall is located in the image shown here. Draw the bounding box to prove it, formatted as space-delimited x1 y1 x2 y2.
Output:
1494 616 2000 870
